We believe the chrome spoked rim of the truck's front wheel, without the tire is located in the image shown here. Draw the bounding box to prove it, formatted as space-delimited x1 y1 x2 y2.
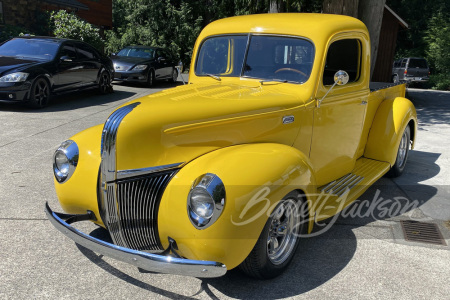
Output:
267 199 300 265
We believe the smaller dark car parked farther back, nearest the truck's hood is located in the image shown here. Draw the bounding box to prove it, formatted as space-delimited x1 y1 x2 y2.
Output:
111 46 178 87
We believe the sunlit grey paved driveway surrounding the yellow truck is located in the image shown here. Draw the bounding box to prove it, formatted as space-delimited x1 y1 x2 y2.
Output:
0 84 450 299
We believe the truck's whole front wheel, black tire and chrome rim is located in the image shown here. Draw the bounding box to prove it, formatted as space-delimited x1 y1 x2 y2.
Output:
239 192 306 279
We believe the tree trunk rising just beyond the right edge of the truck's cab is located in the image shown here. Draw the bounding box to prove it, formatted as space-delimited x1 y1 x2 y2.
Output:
358 0 386 78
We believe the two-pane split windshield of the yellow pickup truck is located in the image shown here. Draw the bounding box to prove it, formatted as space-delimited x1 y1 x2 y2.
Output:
195 35 314 83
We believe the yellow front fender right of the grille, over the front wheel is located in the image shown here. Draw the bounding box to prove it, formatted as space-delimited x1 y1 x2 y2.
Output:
158 143 315 269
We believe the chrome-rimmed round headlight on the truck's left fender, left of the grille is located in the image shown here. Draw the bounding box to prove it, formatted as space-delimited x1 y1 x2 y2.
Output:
53 140 79 183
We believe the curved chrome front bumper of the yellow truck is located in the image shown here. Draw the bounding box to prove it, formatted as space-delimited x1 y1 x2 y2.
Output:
45 203 227 278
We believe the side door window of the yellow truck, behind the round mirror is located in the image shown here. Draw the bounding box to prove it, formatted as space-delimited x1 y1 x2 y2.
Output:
323 39 361 85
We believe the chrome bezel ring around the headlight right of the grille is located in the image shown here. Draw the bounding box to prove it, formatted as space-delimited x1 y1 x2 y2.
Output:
187 173 226 230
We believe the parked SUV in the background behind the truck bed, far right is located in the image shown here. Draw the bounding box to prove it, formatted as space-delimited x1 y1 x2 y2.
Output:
392 57 430 83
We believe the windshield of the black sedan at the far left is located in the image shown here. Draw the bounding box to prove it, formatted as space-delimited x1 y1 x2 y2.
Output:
0 38 60 60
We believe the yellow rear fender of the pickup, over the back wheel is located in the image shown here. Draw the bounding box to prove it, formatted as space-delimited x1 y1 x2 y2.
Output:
364 97 417 166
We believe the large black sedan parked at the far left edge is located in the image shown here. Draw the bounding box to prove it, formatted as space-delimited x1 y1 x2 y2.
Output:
0 37 113 108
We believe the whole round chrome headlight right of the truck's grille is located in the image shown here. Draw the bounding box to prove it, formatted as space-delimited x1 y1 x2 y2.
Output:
188 173 225 229
